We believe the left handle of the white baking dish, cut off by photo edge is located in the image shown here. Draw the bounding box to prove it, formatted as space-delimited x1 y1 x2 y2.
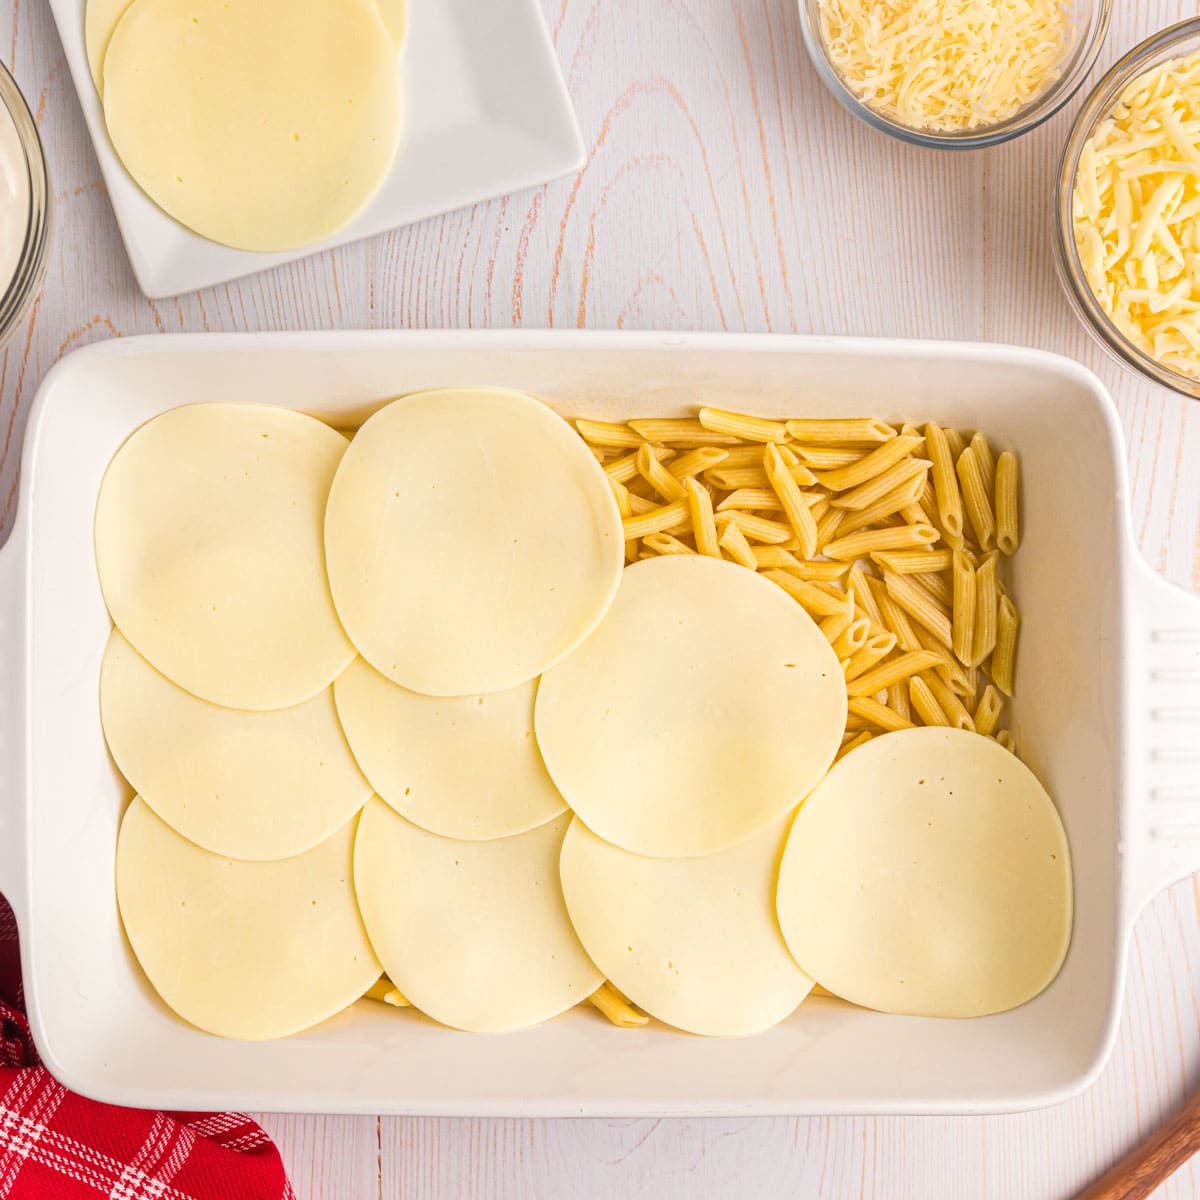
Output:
0 520 26 922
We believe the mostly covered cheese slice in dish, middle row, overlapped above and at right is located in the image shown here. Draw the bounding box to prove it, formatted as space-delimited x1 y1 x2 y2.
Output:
334 659 566 841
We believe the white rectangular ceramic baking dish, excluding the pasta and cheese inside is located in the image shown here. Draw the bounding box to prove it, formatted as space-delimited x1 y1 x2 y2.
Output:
0 332 1200 1115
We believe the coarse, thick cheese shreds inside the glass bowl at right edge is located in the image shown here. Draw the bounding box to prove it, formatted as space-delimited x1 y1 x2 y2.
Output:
1074 52 1200 378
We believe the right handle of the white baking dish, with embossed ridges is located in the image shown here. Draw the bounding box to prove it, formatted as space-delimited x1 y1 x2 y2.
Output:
1124 562 1200 914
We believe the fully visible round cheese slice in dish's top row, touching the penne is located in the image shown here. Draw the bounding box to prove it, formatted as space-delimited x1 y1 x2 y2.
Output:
325 389 624 696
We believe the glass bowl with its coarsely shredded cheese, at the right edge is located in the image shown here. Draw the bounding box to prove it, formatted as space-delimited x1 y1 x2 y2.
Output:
1057 18 1200 398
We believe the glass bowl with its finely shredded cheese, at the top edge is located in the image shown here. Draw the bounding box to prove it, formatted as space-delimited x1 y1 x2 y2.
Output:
799 0 1112 150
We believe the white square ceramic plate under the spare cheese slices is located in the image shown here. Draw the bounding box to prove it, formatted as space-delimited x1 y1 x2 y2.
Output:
50 0 586 299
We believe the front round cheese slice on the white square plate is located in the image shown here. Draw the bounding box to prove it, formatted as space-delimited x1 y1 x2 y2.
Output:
103 0 401 251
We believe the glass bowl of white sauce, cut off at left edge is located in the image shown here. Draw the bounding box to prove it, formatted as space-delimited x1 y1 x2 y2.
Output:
0 65 50 346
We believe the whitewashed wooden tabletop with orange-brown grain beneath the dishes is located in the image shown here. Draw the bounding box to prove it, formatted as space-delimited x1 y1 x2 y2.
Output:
0 0 1200 1200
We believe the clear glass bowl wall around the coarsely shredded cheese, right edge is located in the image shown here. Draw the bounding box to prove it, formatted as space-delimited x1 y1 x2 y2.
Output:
1055 18 1200 400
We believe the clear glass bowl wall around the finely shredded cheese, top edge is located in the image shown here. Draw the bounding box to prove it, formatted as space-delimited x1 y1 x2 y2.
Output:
799 0 1112 150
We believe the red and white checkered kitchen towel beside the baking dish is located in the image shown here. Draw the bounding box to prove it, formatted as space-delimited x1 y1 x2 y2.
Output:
0 896 295 1200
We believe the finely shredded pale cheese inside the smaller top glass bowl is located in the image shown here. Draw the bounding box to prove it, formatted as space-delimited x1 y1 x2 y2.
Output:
820 0 1072 132
